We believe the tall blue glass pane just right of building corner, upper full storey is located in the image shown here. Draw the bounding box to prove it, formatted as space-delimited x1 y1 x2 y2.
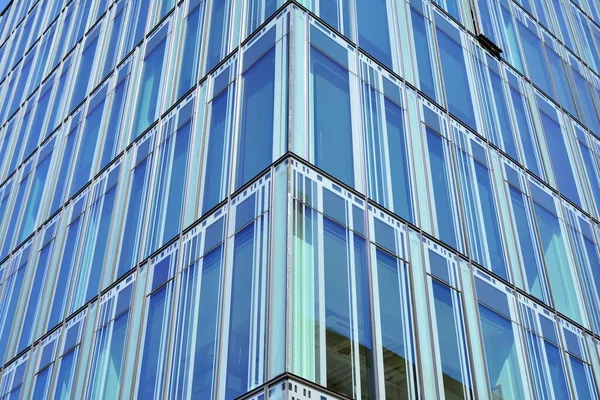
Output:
310 46 354 185
